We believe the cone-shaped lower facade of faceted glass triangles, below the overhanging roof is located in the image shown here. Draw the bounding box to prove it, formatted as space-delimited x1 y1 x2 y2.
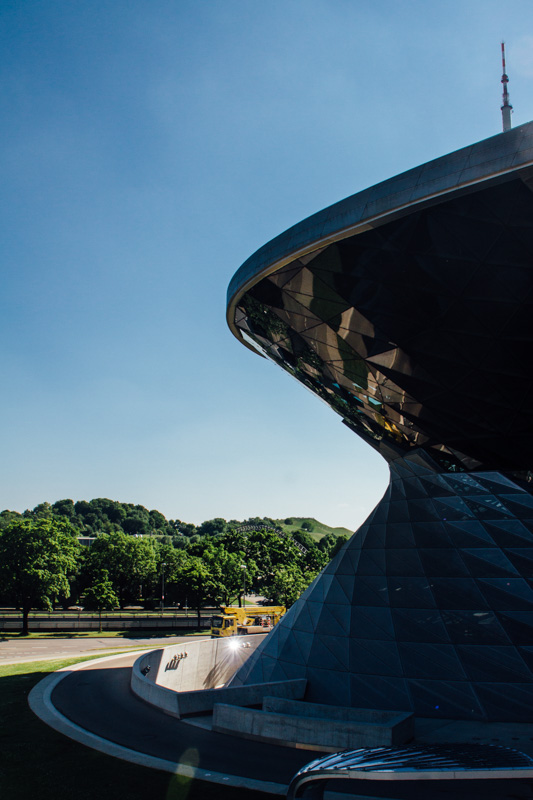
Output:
230 456 533 722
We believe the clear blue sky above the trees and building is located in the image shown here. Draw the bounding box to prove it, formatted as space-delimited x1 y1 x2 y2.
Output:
0 0 533 529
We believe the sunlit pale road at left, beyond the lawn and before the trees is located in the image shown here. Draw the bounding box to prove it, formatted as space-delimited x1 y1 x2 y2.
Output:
0 634 204 665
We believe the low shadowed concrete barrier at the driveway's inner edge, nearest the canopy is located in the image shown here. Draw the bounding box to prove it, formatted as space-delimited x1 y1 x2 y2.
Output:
213 698 412 753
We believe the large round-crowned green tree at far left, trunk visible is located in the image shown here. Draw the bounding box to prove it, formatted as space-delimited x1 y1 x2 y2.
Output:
0 516 79 635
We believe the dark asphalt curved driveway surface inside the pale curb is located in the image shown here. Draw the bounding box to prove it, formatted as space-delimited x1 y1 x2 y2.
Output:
39 656 533 800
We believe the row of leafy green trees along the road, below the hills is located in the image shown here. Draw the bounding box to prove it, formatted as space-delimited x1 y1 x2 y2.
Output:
0 512 345 632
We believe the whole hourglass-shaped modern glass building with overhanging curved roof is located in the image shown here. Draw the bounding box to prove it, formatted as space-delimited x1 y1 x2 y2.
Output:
228 123 533 721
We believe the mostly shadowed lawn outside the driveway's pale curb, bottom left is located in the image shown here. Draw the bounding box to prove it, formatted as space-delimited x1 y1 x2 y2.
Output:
0 654 271 800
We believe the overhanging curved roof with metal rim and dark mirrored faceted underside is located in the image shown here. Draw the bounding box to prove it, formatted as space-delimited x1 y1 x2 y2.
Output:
228 123 533 473
